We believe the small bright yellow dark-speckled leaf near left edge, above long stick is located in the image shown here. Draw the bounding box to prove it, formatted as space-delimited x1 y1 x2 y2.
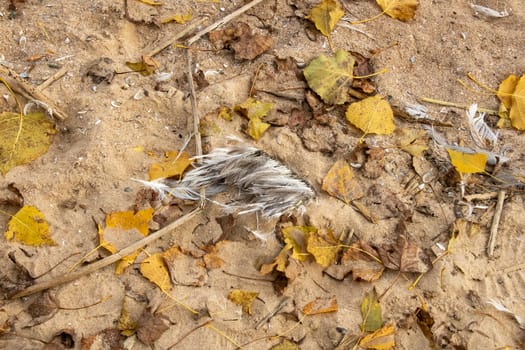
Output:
4 205 57 247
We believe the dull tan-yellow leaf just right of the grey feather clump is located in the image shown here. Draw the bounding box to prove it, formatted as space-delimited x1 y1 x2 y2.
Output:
322 159 363 204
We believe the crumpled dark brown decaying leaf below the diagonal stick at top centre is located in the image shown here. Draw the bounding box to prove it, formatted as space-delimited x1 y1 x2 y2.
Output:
209 22 273 60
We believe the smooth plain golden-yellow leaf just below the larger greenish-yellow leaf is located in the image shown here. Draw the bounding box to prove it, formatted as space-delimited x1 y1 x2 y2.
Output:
346 95 396 135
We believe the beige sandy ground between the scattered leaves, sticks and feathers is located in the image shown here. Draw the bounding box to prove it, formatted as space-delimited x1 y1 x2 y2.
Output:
0 0 525 349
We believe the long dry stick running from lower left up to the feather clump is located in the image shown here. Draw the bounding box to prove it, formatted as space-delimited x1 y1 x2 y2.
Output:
11 208 201 299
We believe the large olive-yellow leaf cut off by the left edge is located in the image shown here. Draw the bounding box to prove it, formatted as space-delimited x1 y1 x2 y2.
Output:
0 112 56 175
